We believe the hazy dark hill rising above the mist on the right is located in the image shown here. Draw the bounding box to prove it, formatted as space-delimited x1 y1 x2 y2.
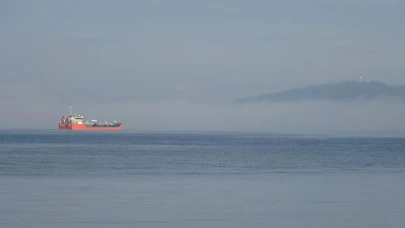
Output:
237 81 405 103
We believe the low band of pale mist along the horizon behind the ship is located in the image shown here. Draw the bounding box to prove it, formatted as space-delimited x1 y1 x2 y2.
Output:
1 100 405 136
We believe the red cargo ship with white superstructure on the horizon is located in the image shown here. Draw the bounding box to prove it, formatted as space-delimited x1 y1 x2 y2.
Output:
59 106 122 131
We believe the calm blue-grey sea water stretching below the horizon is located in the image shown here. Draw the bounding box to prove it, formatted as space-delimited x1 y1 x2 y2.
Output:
0 131 405 228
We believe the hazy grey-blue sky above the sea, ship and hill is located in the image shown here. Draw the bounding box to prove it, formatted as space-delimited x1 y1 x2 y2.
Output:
0 0 405 130
